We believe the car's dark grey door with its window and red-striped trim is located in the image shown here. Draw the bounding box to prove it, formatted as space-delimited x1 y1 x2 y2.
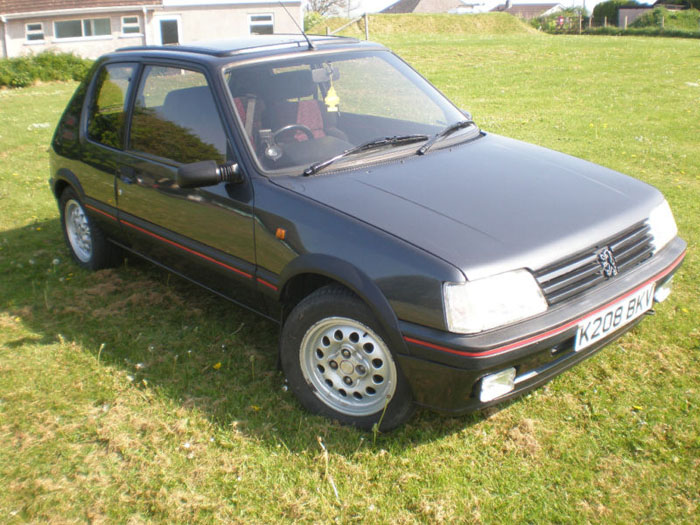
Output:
117 64 260 307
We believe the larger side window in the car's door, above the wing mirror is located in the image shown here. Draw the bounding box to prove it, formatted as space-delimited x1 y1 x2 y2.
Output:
129 66 228 164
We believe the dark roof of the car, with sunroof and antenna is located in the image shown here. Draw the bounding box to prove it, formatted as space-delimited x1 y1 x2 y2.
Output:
115 34 385 62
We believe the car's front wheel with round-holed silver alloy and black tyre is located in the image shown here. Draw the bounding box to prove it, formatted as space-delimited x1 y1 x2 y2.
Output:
280 286 415 431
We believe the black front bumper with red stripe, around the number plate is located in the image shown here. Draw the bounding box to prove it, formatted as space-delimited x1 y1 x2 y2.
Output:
398 237 686 414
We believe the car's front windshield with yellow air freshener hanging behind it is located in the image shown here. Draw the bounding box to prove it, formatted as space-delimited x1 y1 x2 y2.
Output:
225 51 474 173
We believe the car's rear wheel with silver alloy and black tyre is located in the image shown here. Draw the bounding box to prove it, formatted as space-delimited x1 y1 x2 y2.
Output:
58 188 122 270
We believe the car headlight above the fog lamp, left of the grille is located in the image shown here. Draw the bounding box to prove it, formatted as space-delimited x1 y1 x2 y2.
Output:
444 270 547 334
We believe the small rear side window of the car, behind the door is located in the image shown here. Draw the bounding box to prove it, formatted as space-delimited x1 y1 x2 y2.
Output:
87 64 136 149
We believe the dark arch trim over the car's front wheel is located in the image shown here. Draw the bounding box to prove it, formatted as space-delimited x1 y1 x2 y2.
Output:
279 254 407 354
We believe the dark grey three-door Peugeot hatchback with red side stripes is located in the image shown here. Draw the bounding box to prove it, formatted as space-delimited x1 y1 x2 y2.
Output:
50 35 686 429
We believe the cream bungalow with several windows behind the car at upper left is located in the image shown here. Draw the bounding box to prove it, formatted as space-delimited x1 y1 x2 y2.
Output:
0 0 303 58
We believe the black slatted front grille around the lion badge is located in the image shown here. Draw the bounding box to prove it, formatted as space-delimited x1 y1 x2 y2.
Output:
535 221 654 305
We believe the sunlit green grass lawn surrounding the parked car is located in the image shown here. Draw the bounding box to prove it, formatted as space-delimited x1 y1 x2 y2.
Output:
0 30 700 523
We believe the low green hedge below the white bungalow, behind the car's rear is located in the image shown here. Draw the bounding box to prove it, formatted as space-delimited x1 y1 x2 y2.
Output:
0 51 92 88
